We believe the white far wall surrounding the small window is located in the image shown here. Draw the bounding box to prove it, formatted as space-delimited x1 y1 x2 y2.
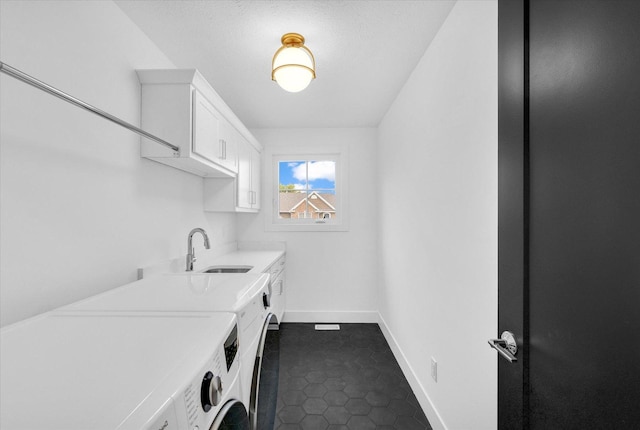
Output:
238 128 377 322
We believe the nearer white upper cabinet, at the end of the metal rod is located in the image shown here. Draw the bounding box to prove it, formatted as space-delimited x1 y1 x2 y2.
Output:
137 69 253 178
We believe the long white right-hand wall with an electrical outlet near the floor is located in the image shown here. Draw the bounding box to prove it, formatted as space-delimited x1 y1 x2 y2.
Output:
378 0 497 430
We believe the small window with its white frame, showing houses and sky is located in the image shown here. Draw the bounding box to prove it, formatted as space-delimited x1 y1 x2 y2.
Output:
266 147 348 231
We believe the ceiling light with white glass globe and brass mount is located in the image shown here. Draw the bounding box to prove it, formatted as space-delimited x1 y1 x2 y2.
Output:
271 33 316 93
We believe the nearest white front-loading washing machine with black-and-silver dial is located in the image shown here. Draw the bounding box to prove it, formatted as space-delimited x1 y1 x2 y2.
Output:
0 312 249 430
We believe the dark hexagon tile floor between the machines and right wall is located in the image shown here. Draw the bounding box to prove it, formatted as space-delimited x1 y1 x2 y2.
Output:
274 323 431 430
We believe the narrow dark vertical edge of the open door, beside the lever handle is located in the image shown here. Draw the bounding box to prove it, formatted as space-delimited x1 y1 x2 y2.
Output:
498 0 529 429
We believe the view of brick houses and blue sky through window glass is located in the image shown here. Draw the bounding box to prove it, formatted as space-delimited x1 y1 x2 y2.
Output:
278 160 338 222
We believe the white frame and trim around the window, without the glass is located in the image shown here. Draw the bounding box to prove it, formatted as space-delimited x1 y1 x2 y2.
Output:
265 145 349 231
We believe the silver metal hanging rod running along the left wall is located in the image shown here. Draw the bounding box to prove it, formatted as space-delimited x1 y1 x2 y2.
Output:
0 62 180 156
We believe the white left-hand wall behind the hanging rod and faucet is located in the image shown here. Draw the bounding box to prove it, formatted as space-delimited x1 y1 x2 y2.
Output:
0 1 236 325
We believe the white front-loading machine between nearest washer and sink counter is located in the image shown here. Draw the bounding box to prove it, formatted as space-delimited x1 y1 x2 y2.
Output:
62 273 279 430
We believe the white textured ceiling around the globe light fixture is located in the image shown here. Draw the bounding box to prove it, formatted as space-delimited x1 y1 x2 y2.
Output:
116 0 455 128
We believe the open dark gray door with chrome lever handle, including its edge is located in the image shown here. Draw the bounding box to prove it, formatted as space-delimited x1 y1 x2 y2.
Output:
498 0 640 429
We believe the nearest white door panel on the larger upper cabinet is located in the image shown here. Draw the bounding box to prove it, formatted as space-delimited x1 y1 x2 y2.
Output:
192 90 222 164
